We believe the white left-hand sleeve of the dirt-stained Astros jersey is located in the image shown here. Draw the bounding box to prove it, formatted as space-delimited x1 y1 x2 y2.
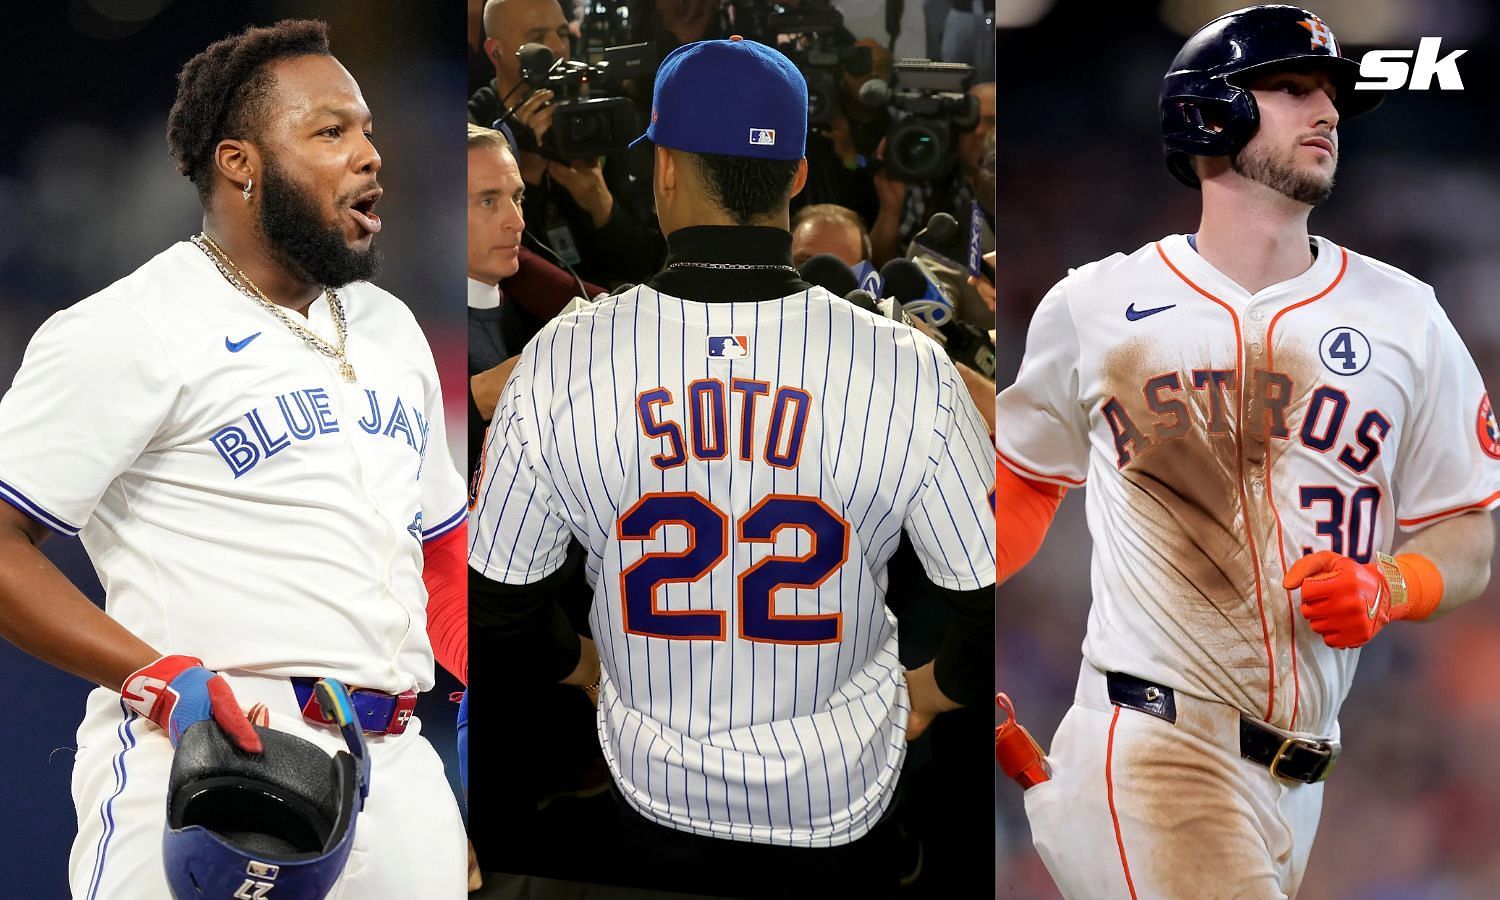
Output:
995 279 1089 488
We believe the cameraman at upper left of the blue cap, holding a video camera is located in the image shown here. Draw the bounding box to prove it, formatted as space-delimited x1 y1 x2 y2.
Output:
468 0 666 287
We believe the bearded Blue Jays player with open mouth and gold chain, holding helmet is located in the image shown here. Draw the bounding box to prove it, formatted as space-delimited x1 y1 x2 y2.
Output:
0 21 467 900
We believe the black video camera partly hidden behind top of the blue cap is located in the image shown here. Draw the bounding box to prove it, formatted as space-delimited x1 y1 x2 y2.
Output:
726 0 875 126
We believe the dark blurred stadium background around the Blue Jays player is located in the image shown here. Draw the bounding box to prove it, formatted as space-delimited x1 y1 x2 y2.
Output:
0 0 467 899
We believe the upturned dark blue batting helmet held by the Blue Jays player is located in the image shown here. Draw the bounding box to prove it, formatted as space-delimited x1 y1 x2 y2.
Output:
162 680 369 900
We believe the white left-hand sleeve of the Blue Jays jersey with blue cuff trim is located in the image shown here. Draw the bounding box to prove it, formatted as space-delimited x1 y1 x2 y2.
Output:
0 297 182 536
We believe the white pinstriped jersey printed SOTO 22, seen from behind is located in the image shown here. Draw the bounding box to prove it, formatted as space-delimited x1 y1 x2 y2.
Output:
470 288 995 846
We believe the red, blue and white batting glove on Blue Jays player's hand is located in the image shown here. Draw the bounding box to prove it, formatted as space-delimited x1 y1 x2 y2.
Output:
120 656 263 753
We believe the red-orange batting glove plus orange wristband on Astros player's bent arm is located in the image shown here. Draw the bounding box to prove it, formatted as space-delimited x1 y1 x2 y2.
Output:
1281 551 1443 650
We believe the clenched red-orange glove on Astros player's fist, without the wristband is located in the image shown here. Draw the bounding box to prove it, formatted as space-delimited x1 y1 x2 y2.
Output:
1281 551 1400 650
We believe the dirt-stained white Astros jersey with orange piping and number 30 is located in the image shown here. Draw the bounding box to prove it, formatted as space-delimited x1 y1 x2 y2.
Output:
998 236 1500 735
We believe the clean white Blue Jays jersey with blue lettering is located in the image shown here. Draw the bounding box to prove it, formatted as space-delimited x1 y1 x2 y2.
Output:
0 242 464 692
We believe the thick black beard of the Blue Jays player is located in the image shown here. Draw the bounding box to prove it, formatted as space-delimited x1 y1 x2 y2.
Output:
257 156 380 288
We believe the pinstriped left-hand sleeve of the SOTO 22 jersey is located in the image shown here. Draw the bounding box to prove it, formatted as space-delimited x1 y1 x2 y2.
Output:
470 342 570 585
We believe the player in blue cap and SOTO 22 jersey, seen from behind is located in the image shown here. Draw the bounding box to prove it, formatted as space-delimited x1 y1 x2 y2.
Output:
470 38 995 896
